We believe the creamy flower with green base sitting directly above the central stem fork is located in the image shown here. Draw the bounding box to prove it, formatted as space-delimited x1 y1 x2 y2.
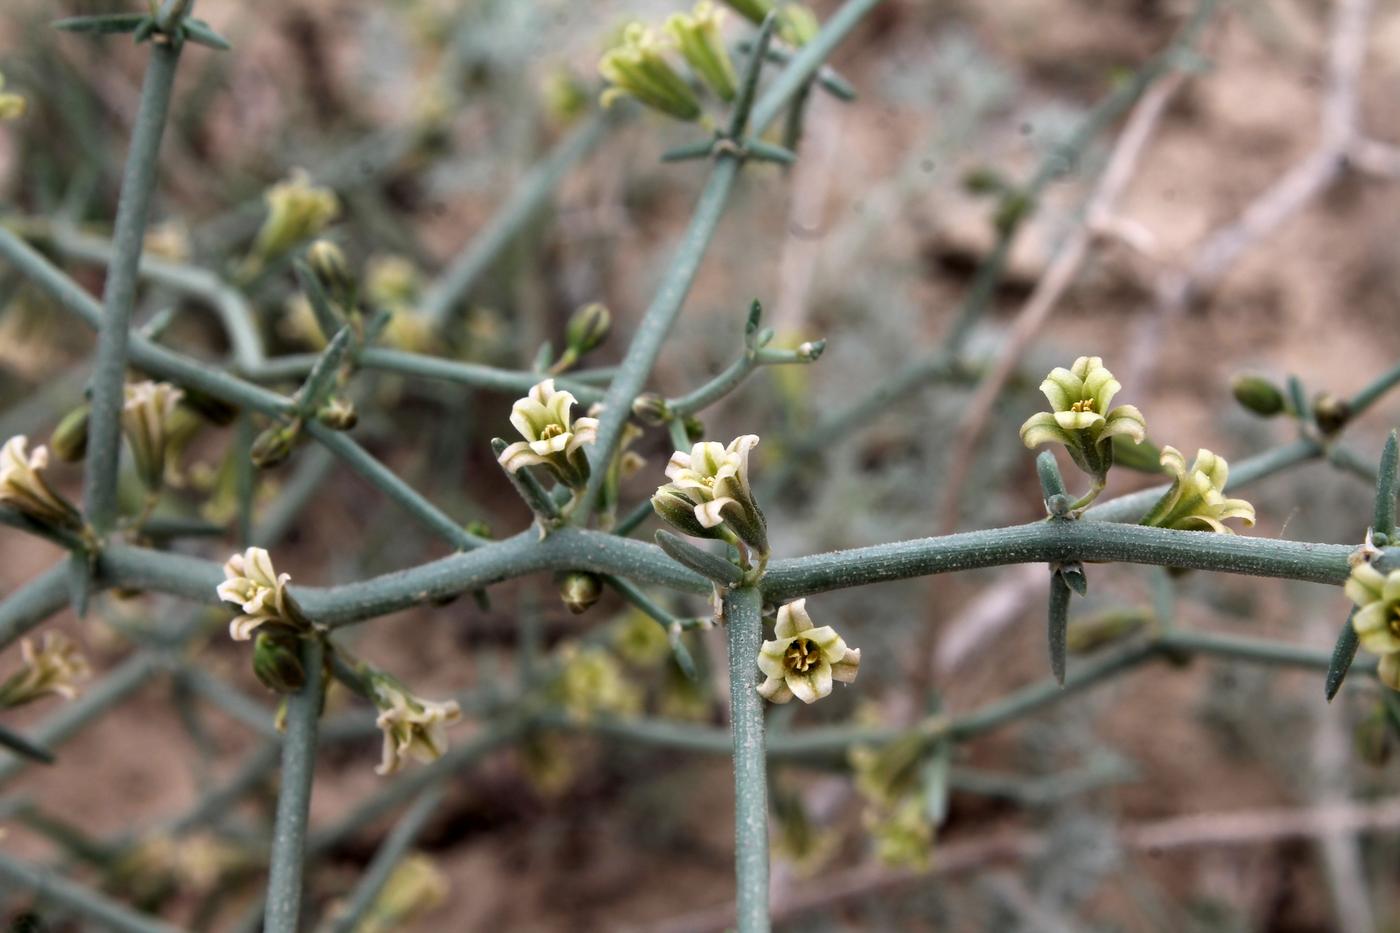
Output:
651 434 769 555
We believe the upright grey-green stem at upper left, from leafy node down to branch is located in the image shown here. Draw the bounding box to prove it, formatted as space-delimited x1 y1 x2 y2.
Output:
83 42 181 535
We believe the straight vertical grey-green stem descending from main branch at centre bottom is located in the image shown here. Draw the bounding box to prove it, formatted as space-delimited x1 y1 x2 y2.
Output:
724 587 770 933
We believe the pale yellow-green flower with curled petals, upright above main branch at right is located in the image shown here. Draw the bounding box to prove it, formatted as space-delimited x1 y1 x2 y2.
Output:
1021 356 1147 478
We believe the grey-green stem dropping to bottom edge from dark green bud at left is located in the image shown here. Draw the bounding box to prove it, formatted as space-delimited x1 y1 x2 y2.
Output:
263 637 325 933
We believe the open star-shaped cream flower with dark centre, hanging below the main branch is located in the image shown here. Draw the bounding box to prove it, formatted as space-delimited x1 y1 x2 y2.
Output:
759 600 861 703
